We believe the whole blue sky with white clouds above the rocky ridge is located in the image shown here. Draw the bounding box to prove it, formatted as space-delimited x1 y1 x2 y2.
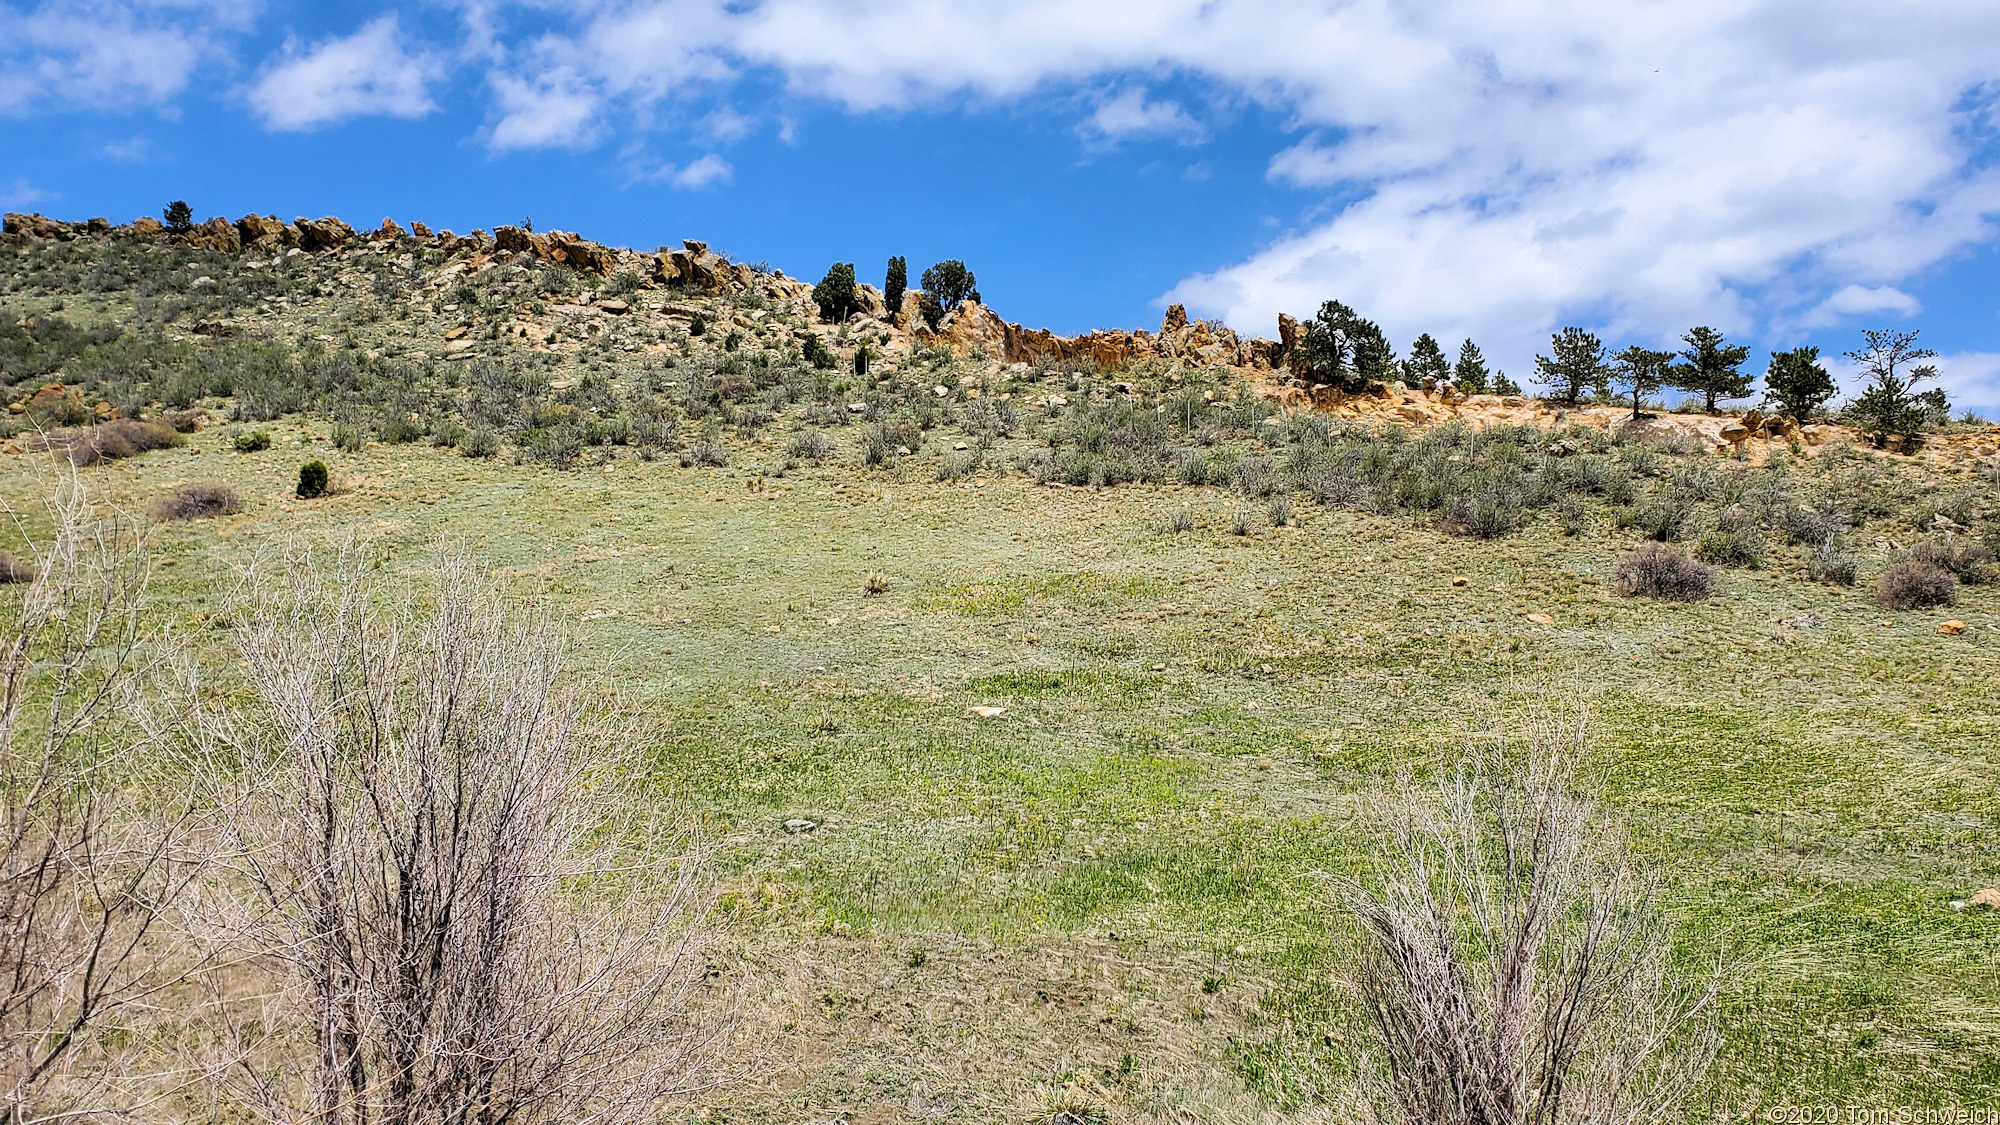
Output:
0 0 2000 406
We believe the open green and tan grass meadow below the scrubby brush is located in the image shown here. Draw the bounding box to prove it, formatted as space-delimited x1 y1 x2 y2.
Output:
0 420 2000 1121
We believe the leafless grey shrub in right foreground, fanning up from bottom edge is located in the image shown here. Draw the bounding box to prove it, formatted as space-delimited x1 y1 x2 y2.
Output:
1336 715 1720 1125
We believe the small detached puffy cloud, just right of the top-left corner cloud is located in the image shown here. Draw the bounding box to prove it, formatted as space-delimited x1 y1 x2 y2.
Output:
250 12 438 130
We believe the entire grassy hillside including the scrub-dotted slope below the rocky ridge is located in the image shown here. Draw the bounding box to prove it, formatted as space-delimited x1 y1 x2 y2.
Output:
0 223 2000 1123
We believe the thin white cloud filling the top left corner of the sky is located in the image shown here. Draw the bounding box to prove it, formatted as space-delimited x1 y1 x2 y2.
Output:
0 0 254 114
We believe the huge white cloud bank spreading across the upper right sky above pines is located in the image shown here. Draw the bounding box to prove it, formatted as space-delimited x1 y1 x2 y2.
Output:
476 0 2000 368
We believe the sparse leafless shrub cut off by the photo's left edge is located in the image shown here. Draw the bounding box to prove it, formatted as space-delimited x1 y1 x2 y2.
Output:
0 476 200 1125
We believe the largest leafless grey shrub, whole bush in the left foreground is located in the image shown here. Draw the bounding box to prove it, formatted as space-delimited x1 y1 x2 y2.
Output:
182 546 718 1125
